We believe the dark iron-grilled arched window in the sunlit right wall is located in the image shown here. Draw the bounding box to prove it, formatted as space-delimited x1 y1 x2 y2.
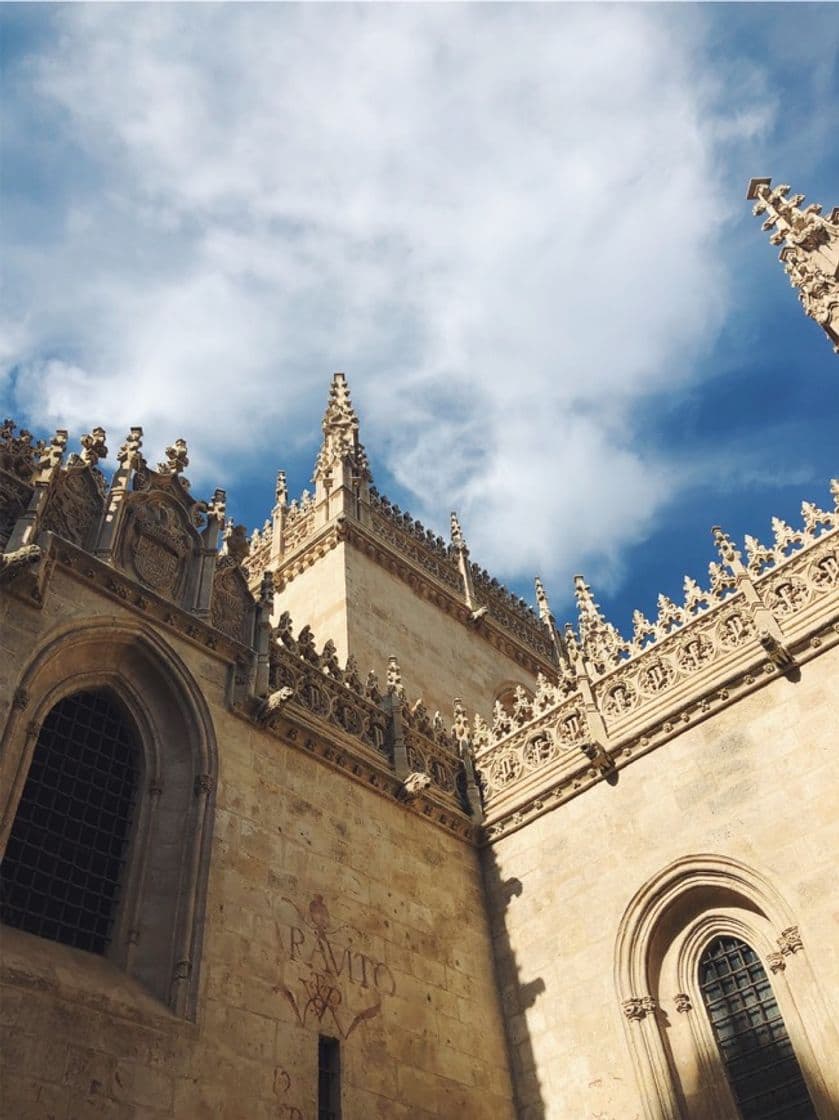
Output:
699 937 817 1120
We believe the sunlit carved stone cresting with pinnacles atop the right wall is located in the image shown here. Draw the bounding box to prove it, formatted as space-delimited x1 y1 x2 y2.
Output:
474 480 839 841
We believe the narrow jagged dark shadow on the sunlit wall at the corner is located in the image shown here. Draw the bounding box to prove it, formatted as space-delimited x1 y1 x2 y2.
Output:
481 848 546 1120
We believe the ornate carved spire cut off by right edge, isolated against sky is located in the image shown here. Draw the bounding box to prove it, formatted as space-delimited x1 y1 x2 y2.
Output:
746 179 839 354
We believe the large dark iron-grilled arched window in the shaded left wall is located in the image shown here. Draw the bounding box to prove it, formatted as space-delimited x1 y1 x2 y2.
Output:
0 691 140 953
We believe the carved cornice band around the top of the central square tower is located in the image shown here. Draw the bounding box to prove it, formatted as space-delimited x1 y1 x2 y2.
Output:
274 515 556 675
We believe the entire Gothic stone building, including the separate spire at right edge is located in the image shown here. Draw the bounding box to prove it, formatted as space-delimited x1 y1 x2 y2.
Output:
0 180 839 1120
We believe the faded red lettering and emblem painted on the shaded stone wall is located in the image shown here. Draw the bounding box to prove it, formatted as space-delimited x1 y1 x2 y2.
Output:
274 895 397 1039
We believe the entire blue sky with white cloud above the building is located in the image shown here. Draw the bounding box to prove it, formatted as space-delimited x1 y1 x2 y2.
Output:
0 3 839 625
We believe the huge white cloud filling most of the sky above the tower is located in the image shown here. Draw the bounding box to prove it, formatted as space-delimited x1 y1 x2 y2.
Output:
0 4 770 591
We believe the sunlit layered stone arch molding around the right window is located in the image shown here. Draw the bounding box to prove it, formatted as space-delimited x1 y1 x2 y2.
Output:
614 853 839 1120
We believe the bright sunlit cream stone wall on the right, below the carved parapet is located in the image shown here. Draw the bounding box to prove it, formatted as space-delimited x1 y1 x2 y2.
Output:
484 647 839 1120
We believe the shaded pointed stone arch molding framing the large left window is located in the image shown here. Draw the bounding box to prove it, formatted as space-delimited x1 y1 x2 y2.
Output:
0 618 218 1019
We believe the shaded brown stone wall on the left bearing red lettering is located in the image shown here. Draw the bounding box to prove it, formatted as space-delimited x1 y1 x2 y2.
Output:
0 566 513 1120
